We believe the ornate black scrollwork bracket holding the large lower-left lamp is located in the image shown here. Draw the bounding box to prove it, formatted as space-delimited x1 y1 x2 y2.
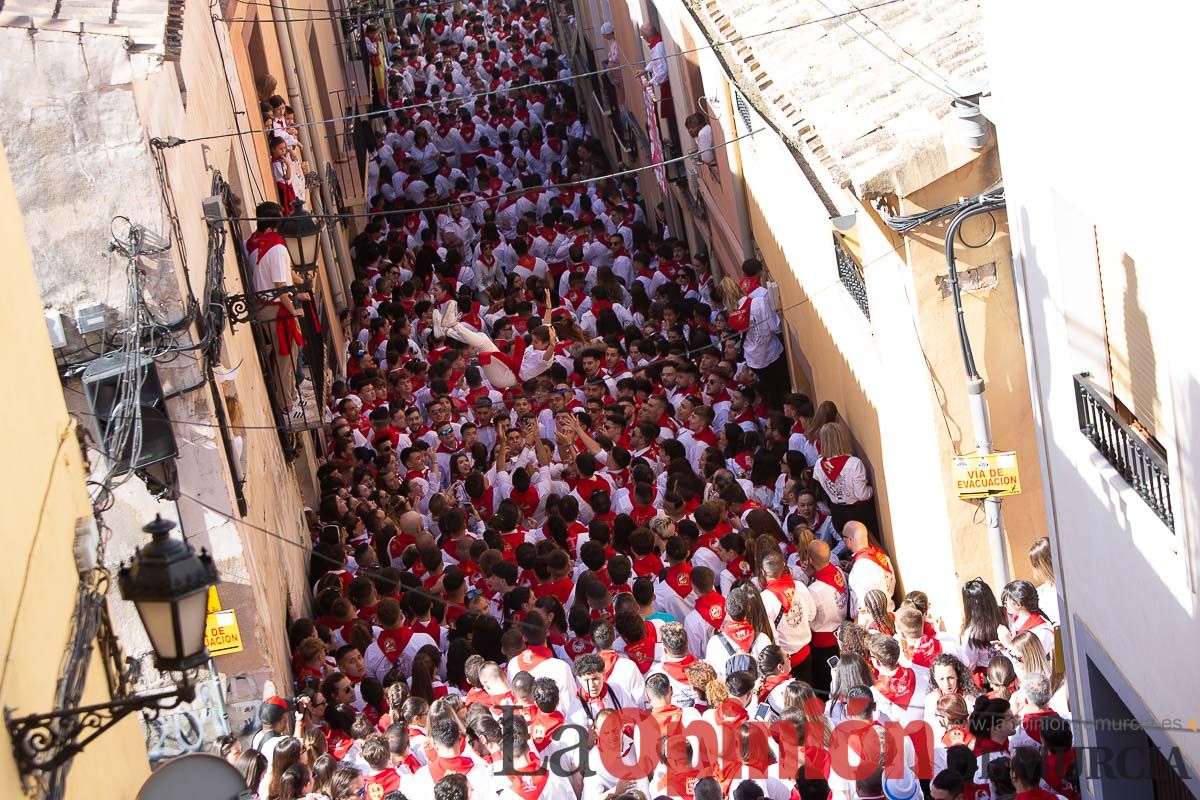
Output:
5 682 196 775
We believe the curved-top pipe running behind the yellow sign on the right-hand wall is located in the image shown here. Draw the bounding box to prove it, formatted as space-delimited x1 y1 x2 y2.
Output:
946 198 1012 588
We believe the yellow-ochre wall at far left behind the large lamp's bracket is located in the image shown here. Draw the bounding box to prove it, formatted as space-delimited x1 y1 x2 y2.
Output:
0 142 150 800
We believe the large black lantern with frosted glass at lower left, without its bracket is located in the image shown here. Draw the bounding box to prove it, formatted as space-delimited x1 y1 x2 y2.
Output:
118 516 220 672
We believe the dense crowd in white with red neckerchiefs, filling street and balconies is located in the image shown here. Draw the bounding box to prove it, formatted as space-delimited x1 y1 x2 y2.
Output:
229 0 1078 800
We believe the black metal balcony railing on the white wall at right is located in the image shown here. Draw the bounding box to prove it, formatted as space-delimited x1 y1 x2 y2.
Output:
1075 372 1175 531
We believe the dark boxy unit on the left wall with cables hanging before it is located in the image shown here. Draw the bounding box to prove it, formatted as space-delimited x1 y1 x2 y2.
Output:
83 350 179 474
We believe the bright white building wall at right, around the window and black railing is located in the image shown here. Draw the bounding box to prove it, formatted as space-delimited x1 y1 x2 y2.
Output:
985 0 1200 796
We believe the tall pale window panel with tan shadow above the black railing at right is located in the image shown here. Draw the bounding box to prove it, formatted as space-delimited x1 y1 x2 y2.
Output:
1096 225 1168 438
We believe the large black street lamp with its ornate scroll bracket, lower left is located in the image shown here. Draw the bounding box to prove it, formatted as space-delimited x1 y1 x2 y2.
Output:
5 517 220 777
